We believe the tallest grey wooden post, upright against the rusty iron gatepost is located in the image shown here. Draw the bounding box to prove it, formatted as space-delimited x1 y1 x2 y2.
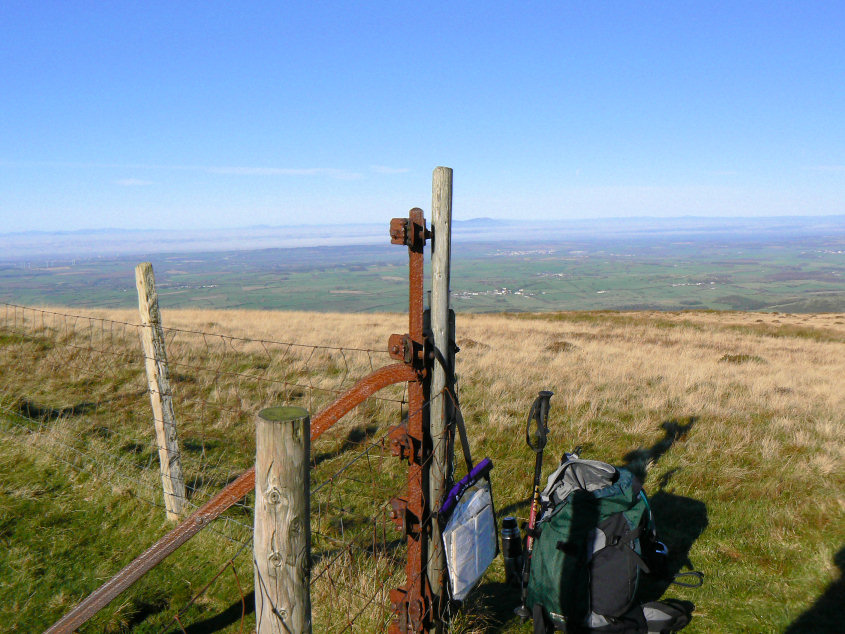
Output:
428 167 454 631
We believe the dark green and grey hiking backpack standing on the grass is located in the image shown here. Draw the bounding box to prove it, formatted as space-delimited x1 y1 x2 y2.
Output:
525 454 658 632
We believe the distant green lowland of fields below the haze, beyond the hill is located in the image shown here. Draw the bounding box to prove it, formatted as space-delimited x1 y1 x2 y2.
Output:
0 234 845 312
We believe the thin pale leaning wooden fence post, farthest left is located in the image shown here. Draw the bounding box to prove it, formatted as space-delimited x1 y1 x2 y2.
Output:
135 262 186 520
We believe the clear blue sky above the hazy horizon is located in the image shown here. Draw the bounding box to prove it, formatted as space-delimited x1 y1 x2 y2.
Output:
0 0 845 232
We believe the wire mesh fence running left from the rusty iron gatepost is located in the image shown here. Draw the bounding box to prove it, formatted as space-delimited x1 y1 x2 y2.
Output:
0 304 416 632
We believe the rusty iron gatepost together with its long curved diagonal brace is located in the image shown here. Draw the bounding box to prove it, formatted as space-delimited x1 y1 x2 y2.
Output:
47 208 438 633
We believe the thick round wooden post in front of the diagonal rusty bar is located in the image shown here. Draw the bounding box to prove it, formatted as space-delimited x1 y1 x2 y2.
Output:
253 407 311 634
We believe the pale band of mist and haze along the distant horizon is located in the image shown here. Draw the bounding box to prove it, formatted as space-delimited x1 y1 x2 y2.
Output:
0 214 845 263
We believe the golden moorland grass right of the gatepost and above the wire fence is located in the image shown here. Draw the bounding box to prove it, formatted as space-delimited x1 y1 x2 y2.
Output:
8 310 845 632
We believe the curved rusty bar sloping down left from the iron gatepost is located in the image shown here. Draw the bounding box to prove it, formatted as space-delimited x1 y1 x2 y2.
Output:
46 363 418 634
